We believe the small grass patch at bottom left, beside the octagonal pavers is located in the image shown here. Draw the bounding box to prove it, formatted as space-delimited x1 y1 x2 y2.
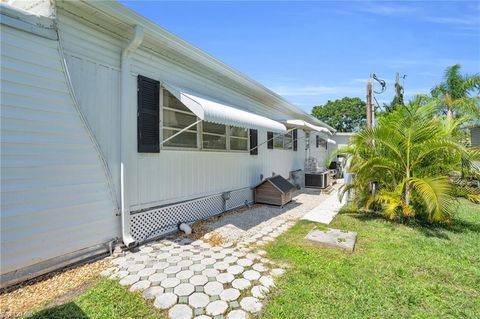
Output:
26 279 164 319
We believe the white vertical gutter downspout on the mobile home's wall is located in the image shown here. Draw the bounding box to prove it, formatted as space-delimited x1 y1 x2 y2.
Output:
120 25 144 248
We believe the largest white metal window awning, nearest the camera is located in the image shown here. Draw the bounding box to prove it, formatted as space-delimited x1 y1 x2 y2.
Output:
162 83 287 134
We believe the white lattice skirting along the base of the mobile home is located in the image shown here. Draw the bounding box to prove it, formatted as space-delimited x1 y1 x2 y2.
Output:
130 188 253 242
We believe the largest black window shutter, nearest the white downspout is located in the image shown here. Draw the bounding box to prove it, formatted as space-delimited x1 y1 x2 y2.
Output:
137 75 160 153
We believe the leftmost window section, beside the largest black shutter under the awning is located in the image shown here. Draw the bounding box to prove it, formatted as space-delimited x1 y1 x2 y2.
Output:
162 89 198 148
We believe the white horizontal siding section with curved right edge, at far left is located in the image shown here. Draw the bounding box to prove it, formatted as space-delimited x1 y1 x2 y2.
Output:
1 25 119 275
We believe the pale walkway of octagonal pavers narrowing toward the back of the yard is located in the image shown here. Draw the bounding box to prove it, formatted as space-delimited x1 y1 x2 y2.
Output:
102 186 342 319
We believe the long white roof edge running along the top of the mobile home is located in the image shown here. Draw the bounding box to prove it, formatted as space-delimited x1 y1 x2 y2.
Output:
70 0 336 132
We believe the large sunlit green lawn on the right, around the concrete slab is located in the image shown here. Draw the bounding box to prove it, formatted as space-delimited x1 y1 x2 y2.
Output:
262 201 480 318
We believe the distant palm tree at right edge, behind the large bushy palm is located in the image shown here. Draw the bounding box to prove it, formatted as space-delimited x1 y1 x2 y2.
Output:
431 64 480 120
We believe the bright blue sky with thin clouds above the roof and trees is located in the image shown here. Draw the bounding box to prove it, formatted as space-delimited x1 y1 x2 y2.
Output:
121 1 480 112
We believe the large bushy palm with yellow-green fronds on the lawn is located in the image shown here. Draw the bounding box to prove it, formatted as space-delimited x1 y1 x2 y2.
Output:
343 99 480 222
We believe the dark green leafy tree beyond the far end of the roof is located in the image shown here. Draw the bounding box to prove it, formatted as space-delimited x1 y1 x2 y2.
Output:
312 97 367 132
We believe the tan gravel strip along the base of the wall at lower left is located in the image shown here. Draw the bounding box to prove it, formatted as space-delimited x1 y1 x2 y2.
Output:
0 259 111 318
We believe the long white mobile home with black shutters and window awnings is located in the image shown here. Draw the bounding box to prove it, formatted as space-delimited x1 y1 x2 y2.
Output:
1 0 334 285
